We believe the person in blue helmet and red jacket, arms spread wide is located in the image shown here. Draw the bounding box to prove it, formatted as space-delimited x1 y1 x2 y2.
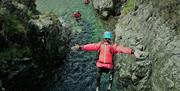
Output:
71 31 142 91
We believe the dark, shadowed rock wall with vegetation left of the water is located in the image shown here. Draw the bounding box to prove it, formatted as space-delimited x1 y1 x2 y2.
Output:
0 0 70 91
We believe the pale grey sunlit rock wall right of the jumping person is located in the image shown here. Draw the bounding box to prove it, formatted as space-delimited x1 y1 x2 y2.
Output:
114 0 180 91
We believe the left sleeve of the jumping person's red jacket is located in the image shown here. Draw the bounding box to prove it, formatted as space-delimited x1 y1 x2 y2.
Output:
80 43 100 51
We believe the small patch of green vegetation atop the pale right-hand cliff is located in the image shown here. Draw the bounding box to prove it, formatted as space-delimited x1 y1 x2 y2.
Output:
121 0 136 15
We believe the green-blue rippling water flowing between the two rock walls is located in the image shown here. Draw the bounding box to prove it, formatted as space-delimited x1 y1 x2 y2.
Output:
36 0 112 91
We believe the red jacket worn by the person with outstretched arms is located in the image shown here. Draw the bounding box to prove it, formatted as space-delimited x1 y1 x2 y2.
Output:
80 42 132 69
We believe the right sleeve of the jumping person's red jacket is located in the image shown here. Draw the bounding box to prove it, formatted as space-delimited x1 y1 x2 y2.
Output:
113 44 134 54
